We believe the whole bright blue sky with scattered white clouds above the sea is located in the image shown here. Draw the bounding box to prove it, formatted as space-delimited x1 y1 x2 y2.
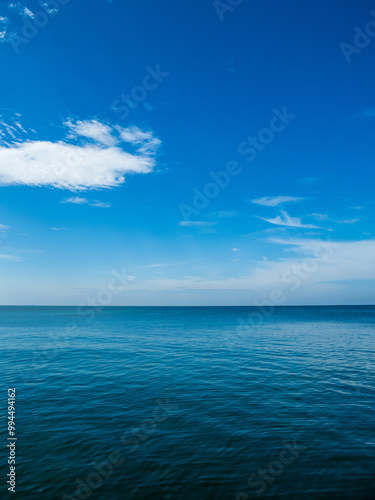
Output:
0 0 375 305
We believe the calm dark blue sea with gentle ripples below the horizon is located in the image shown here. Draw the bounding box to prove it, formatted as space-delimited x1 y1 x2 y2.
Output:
0 307 375 500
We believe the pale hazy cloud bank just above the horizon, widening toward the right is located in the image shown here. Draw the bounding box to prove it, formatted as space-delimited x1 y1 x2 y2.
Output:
122 239 375 304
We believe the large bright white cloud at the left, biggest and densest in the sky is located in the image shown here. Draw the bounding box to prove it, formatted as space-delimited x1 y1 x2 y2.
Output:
0 120 160 191
